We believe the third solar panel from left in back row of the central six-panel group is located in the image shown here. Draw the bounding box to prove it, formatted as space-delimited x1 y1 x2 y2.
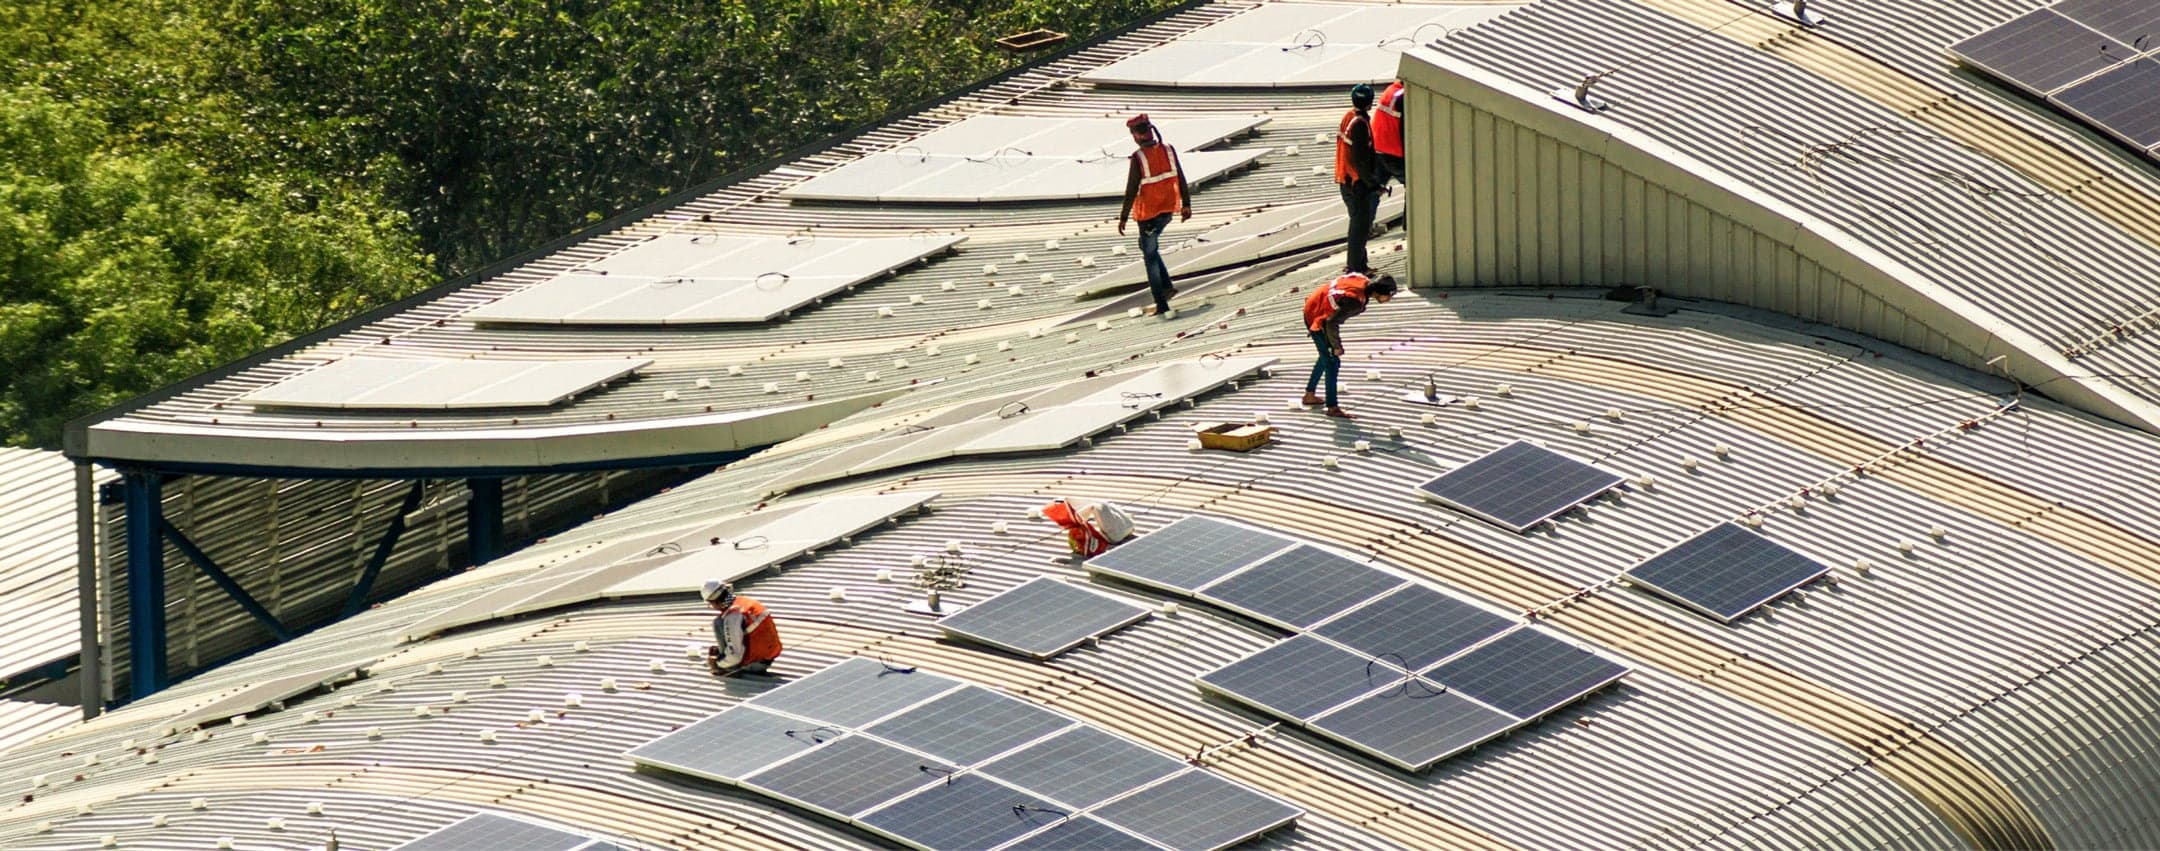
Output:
1315 585 1514 672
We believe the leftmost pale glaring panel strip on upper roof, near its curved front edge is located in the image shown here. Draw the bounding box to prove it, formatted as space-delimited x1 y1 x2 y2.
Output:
240 356 652 410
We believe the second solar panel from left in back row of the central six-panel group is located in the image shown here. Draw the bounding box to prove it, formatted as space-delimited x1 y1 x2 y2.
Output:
1201 544 1404 631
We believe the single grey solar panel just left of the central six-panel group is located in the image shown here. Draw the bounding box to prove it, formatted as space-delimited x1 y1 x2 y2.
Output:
937 577 1147 659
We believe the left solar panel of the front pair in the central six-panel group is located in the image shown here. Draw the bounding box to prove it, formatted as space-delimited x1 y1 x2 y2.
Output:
1199 635 1404 719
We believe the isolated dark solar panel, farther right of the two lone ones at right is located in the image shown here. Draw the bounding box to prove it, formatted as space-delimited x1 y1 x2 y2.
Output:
1626 522 1831 624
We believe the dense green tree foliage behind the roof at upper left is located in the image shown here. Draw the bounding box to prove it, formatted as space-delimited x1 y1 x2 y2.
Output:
0 0 1169 445
